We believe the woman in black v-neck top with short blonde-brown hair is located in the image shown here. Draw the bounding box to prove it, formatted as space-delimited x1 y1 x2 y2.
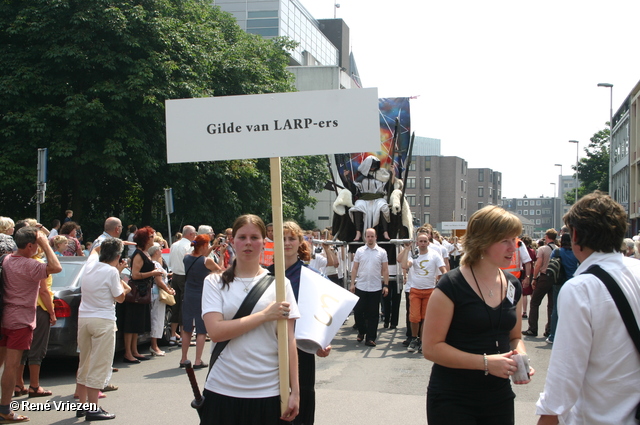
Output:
422 206 534 425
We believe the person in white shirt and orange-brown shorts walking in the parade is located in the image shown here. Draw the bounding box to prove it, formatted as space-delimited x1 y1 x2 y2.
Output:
398 232 447 352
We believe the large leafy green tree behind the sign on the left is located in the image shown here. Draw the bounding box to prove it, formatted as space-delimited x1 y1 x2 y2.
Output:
0 0 324 237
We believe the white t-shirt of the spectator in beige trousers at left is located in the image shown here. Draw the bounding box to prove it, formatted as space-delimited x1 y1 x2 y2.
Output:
78 254 123 321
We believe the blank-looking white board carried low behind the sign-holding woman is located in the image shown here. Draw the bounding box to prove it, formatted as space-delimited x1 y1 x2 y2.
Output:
296 267 358 354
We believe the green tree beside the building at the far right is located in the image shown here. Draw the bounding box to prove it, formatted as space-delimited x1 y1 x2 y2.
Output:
565 123 610 204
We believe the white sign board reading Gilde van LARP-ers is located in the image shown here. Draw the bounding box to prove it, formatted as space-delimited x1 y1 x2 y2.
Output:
166 88 380 163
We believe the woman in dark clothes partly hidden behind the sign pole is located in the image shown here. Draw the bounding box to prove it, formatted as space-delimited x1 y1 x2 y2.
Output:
270 221 331 425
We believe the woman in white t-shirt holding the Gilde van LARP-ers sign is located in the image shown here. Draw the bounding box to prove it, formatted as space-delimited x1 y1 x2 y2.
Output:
201 215 300 425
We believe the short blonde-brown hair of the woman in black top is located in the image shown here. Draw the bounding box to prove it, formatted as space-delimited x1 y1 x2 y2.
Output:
460 205 522 266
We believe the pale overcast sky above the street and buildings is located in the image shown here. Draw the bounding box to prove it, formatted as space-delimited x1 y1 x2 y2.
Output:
300 0 640 198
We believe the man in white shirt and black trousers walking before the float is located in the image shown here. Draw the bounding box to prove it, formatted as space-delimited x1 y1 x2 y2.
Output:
350 229 389 347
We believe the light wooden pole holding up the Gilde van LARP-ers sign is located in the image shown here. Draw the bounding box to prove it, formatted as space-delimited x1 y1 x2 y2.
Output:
270 157 289 414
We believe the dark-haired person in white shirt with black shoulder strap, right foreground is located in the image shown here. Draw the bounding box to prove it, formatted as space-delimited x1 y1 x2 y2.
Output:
536 191 640 425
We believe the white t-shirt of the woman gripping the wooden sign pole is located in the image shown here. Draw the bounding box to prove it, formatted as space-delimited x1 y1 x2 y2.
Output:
202 270 300 398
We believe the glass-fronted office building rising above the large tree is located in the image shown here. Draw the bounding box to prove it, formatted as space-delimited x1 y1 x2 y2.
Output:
214 0 339 66
